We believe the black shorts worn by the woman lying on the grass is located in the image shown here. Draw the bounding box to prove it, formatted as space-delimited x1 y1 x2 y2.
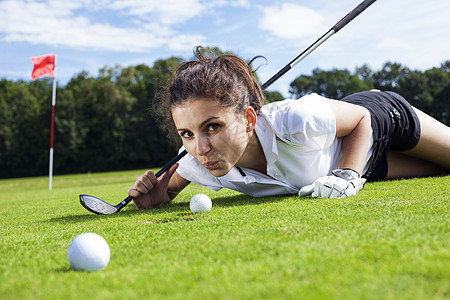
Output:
342 91 420 181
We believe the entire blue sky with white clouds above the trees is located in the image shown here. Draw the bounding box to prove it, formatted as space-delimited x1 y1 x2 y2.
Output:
0 0 450 96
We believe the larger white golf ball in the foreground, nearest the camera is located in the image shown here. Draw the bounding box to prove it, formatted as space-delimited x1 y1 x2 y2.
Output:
67 232 111 271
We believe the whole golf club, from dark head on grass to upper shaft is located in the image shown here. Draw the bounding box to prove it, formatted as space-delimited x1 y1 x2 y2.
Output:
80 0 376 215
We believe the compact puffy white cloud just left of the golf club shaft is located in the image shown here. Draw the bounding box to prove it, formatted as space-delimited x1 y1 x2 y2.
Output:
259 3 323 39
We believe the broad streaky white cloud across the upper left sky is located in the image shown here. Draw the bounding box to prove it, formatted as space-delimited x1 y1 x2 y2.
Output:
0 0 243 52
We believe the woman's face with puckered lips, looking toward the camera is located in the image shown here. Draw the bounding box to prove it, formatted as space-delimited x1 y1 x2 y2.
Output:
172 99 251 177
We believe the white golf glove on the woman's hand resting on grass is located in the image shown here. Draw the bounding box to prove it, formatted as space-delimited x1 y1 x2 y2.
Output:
298 169 367 198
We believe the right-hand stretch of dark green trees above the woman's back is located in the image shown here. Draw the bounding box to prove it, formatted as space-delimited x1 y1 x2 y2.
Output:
289 61 450 125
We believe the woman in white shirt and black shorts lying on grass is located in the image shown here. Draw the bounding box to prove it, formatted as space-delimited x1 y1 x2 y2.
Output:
128 47 450 209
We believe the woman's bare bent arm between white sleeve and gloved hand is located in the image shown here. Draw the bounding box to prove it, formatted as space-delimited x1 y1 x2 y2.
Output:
330 100 371 175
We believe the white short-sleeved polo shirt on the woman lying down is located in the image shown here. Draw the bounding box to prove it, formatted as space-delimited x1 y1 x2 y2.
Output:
177 94 372 197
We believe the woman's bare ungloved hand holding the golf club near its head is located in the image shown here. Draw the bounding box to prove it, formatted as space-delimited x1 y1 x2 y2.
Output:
128 164 178 209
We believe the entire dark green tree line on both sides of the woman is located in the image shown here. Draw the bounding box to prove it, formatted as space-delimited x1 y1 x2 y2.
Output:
0 57 450 178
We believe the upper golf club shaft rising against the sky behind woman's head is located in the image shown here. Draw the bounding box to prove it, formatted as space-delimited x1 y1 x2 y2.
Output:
262 0 376 90
